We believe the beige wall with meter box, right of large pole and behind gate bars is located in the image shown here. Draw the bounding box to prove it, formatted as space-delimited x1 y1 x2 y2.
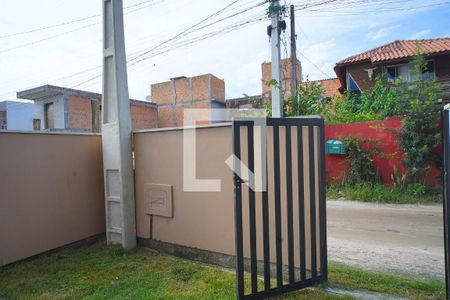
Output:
134 126 320 268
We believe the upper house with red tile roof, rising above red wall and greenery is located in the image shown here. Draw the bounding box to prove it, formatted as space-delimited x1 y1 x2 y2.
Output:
334 38 450 101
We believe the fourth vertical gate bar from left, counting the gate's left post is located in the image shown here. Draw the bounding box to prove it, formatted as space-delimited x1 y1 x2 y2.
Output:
273 125 283 287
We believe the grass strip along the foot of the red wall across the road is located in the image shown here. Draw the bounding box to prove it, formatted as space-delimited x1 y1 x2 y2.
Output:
327 184 442 204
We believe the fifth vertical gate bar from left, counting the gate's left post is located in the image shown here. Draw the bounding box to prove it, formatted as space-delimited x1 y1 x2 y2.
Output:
286 125 295 284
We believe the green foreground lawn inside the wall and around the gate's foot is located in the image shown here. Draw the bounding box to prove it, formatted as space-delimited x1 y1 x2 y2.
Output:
0 242 444 299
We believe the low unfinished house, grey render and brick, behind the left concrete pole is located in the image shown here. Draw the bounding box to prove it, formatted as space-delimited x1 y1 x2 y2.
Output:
17 85 158 132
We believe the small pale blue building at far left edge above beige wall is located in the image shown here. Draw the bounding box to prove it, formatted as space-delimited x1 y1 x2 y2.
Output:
0 101 34 130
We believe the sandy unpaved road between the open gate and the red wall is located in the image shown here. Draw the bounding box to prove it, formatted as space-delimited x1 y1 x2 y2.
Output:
327 201 444 278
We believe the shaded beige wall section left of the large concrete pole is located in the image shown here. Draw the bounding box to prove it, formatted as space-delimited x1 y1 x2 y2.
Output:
0 132 105 266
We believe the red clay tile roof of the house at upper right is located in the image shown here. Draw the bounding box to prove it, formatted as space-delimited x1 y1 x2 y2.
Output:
336 38 450 66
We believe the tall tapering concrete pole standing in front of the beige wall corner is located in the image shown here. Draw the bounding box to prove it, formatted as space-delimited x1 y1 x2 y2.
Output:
101 0 136 249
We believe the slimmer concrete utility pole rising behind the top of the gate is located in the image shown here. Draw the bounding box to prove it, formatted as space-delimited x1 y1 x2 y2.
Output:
269 0 283 118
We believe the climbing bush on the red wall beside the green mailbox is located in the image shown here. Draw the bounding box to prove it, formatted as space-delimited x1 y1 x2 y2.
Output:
342 135 381 185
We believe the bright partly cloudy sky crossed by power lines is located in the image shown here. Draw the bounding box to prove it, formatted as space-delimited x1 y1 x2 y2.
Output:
0 0 450 101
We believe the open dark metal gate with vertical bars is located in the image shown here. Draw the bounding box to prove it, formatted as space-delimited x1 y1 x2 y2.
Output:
232 117 328 299
